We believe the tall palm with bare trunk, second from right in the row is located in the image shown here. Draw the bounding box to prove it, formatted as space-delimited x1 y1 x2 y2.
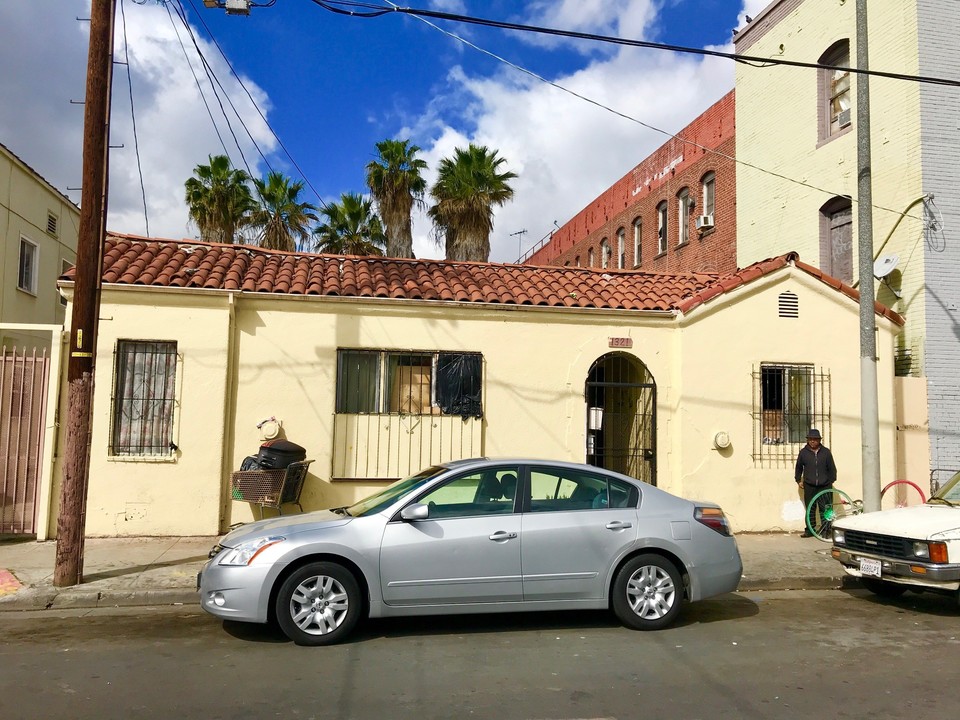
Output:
367 140 427 257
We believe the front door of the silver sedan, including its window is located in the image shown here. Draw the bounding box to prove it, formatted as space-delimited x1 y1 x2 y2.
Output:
380 467 523 605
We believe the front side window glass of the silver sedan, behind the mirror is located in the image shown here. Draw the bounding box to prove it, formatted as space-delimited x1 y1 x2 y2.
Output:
417 467 517 519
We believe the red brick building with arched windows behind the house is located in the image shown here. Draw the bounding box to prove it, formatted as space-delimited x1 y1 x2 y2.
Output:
525 90 737 273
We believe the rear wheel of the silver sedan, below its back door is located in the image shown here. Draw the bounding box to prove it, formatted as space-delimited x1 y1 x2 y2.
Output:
613 555 683 630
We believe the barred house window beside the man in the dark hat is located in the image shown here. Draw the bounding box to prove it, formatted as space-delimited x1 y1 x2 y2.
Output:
753 363 830 460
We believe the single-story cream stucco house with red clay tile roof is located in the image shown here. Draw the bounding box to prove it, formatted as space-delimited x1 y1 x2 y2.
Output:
38 235 902 538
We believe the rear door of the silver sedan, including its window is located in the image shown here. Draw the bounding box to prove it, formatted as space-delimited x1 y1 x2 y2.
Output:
521 466 639 602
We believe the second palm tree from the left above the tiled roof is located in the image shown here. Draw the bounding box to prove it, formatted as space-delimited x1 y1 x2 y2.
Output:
250 171 317 252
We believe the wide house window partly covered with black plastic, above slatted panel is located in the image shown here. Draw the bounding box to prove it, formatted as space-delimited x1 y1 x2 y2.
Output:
337 350 482 418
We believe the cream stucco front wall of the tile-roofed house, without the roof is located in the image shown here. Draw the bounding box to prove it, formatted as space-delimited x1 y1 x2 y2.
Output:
44 269 895 536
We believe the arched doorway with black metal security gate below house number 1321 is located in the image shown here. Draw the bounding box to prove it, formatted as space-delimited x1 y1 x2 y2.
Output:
585 353 657 485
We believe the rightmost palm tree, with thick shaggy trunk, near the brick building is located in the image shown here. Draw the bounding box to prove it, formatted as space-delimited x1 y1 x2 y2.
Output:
429 143 517 262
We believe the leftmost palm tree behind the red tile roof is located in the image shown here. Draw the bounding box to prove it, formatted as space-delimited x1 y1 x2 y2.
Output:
183 155 254 243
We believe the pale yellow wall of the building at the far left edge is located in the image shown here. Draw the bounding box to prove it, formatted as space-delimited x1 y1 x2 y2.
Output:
0 145 80 349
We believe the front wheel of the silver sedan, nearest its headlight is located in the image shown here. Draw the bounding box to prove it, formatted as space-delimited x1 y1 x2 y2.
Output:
276 562 362 645
